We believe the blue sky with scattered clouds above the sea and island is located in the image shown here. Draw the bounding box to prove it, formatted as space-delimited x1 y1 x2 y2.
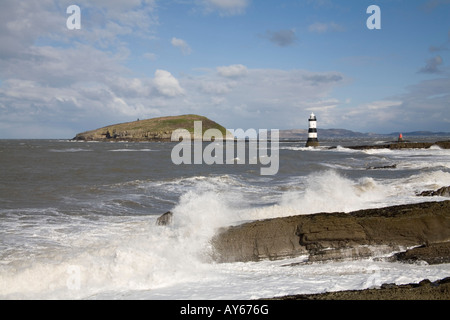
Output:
0 0 450 139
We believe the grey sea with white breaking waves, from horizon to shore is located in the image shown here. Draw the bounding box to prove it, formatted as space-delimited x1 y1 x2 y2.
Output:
0 137 450 300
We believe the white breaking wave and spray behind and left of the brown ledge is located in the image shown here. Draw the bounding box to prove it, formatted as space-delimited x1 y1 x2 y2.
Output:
0 170 450 299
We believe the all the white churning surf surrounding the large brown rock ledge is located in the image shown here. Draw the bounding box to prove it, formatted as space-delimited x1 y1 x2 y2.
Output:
0 140 450 299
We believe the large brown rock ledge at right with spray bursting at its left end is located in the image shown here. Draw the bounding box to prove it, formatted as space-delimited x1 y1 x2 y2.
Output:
212 201 450 262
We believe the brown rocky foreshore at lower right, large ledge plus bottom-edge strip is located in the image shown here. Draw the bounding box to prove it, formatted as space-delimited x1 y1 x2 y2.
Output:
212 200 450 300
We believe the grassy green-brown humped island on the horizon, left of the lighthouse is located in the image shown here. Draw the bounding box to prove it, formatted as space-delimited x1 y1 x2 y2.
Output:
73 114 229 142
